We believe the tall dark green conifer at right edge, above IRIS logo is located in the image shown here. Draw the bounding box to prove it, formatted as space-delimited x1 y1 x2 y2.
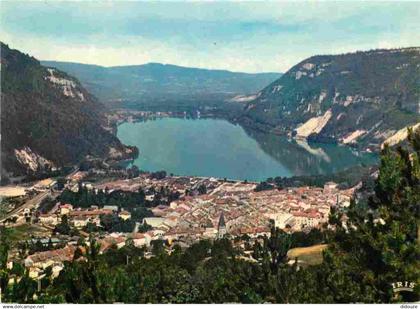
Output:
324 130 420 303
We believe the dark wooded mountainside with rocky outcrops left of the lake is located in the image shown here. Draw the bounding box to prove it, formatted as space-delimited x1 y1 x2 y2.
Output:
1 43 133 183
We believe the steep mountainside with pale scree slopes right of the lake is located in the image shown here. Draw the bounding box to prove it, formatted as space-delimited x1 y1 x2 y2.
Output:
243 48 420 148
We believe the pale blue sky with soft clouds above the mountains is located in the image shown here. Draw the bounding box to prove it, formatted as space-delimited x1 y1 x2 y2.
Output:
0 0 420 72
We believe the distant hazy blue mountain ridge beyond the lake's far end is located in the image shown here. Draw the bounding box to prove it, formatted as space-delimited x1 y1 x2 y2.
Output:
41 61 281 109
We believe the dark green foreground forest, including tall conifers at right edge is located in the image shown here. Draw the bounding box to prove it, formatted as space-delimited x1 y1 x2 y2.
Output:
0 131 420 303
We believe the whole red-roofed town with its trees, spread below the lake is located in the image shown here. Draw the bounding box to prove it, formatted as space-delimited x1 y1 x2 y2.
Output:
0 171 355 279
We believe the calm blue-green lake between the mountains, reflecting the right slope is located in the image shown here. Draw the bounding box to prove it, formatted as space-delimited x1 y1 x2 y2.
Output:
117 118 377 181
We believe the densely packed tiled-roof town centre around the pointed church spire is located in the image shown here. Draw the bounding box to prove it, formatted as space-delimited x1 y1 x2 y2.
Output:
144 182 353 240
